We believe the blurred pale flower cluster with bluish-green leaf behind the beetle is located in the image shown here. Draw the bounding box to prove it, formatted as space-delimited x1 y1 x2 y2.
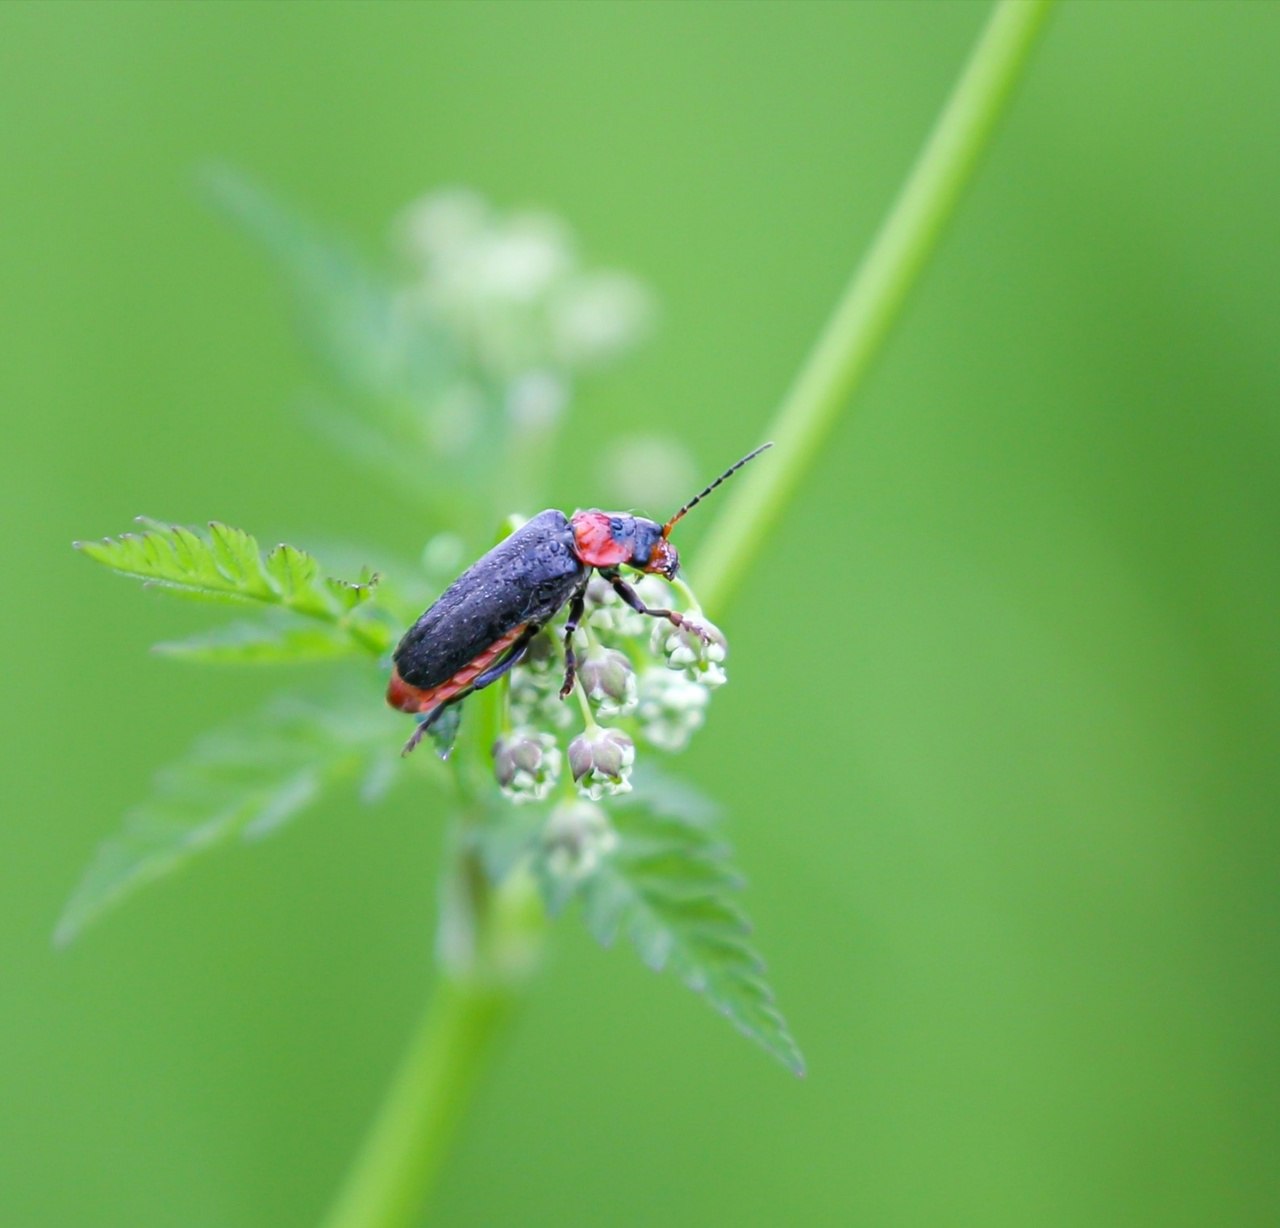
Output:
205 166 653 525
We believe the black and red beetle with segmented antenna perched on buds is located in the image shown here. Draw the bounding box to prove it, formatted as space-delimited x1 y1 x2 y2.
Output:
387 443 772 754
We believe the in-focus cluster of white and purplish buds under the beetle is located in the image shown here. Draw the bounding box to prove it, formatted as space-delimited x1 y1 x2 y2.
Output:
494 576 727 802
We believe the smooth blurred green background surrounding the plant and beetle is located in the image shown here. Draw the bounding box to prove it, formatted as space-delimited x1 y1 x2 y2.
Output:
0 3 1280 1228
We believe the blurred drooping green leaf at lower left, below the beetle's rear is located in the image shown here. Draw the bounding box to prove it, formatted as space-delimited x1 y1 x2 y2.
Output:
54 697 398 945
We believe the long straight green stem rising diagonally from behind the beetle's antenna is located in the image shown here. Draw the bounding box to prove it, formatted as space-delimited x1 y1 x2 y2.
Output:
698 0 1052 613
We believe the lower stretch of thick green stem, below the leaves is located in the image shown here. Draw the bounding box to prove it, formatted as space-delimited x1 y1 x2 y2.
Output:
316 976 516 1228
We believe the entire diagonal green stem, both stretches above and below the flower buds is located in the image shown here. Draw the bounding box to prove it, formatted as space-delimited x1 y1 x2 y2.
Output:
312 0 1052 1228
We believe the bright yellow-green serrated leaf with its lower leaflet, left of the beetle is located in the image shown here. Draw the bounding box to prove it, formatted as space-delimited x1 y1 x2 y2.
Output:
74 517 393 661
